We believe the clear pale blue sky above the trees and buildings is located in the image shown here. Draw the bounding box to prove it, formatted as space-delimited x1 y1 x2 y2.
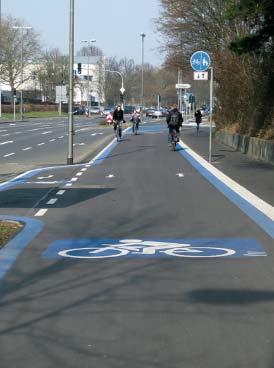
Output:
2 0 163 66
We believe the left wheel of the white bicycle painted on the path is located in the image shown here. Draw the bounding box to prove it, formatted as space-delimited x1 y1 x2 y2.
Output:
58 247 128 259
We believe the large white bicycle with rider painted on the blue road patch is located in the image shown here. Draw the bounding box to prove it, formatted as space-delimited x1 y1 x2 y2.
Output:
58 239 236 259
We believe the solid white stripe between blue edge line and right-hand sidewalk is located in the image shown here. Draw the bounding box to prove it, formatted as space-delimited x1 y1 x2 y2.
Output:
179 141 274 221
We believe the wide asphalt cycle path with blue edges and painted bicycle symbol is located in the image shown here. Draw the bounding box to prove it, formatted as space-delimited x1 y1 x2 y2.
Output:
0 124 274 368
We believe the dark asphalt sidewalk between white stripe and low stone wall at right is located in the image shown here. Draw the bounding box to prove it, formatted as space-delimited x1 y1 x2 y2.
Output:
181 126 274 206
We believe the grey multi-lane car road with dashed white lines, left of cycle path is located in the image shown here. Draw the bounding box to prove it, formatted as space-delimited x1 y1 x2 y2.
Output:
0 117 112 181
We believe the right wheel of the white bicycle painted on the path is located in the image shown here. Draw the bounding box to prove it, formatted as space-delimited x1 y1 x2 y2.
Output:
163 247 236 258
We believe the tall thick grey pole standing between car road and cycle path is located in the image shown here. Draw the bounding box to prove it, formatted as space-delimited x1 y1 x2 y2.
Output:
67 0 74 165
